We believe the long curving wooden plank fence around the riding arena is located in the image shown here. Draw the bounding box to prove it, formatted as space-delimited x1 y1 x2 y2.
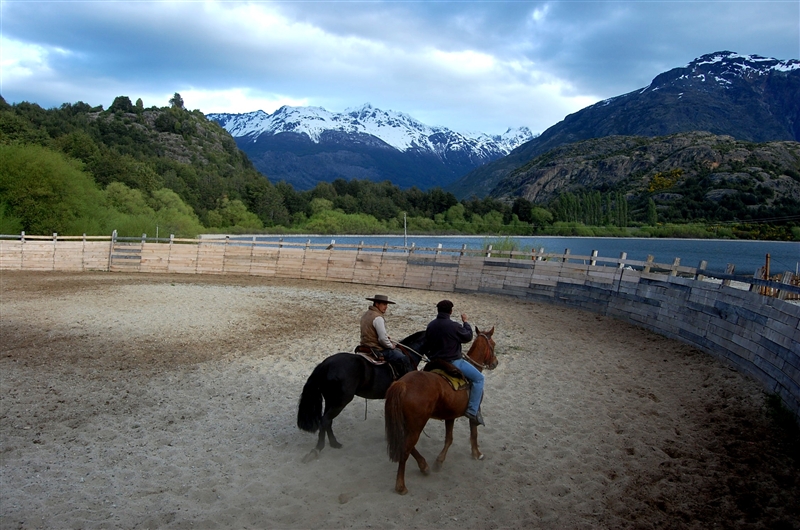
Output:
0 230 800 417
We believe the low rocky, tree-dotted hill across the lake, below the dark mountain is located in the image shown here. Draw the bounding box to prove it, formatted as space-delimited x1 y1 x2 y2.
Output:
492 132 800 236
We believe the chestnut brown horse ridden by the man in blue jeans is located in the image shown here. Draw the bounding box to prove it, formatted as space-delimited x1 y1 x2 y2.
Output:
385 326 497 495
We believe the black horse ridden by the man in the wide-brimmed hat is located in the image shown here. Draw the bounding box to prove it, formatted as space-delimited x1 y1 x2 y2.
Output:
297 331 425 462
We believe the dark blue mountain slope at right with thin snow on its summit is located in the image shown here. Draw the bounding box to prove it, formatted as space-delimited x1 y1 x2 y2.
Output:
447 51 800 198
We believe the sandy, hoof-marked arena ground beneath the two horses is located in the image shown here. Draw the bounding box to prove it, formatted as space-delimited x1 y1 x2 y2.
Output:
0 271 800 529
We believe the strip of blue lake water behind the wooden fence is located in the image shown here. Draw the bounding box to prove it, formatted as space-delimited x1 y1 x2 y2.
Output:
248 235 800 276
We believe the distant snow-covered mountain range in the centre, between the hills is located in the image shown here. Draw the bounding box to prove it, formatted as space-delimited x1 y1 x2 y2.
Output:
207 104 534 189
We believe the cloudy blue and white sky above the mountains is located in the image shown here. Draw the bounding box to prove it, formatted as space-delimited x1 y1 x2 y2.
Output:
0 0 800 134
